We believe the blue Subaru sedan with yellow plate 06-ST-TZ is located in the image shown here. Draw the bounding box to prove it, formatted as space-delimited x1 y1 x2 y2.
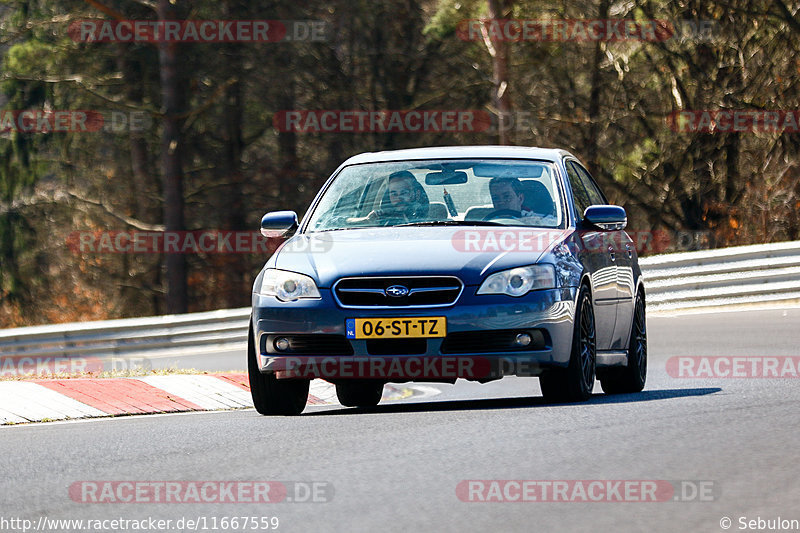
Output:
248 146 647 415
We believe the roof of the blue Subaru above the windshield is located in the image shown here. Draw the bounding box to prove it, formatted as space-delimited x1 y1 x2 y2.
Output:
341 146 574 167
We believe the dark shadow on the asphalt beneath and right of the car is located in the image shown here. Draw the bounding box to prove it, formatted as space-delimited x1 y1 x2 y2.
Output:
302 387 722 416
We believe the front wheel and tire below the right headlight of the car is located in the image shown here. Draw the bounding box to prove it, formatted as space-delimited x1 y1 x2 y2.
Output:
539 285 597 402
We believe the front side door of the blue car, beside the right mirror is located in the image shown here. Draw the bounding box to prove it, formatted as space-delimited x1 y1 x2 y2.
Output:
564 160 617 350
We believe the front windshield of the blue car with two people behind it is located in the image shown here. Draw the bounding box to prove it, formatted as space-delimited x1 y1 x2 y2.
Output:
306 159 564 232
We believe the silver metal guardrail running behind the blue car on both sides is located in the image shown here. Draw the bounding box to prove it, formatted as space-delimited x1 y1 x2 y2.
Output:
0 241 800 357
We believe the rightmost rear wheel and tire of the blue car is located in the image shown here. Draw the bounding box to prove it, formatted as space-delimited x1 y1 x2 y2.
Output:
600 292 647 394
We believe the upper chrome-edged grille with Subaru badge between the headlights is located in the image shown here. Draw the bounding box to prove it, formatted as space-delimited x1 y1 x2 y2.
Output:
334 276 464 308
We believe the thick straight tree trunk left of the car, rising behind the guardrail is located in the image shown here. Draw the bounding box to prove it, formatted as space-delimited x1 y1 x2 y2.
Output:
158 0 189 313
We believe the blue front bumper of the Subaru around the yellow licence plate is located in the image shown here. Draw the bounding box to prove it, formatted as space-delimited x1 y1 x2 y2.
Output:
252 286 577 382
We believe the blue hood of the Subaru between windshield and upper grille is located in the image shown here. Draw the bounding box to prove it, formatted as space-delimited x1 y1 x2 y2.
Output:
274 226 568 287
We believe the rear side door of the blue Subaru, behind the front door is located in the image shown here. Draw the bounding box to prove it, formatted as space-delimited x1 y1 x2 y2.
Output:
573 162 634 350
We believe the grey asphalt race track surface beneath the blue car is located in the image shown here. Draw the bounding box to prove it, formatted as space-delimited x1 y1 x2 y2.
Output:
0 308 800 532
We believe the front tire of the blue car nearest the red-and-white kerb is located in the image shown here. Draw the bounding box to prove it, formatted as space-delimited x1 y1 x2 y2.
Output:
247 320 311 416
